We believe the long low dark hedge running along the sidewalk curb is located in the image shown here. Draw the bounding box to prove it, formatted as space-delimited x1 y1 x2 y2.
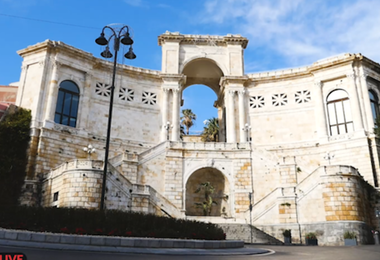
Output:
0 206 225 240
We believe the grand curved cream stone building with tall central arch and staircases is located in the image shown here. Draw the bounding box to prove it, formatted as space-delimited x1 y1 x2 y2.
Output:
11 32 380 245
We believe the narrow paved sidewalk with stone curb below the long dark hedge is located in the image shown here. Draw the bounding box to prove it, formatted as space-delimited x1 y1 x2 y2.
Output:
0 239 274 256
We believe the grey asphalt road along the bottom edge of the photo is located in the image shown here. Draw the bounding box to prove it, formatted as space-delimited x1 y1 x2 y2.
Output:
0 245 380 260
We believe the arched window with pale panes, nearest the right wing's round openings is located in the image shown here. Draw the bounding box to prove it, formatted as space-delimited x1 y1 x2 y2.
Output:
327 89 354 135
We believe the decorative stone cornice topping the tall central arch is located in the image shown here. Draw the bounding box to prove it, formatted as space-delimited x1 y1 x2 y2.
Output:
158 31 248 49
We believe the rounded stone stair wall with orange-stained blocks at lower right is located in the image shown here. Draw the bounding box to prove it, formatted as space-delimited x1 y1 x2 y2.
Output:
251 166 378 245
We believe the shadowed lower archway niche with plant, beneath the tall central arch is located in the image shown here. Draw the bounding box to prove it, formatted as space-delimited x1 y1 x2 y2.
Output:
186 167 230 217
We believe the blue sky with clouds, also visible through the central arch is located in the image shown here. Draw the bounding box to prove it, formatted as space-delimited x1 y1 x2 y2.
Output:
0 0 380 131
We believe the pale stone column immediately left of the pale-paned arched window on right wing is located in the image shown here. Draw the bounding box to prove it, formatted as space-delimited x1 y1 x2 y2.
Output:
314 81 330 138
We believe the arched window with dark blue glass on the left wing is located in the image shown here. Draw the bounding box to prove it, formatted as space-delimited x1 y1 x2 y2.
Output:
54 80 79 127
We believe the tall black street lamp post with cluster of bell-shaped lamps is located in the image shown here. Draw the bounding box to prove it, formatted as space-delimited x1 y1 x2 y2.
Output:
95 25 136 210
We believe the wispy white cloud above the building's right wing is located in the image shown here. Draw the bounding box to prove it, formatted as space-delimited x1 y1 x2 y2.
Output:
199 0 380 66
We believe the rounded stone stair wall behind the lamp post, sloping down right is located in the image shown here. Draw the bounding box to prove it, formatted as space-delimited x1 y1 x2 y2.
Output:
42 160 183 218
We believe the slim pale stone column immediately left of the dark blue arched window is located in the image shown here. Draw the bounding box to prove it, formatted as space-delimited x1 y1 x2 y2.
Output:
44 61 59 122
